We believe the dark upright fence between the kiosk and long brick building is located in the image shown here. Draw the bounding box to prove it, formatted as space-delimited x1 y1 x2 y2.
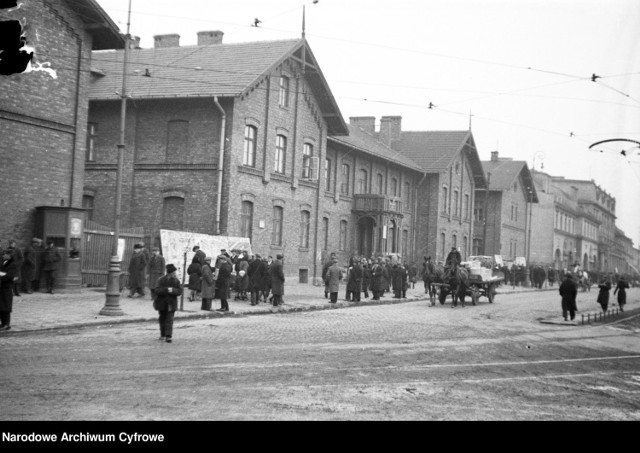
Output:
82 220 146 289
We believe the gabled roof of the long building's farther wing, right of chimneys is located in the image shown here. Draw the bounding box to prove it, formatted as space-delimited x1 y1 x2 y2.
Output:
392 131 486 189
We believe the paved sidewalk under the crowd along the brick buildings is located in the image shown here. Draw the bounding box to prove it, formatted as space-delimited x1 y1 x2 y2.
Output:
2 282 557 335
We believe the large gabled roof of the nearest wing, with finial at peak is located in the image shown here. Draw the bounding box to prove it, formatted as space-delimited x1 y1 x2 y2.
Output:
89 39 347 135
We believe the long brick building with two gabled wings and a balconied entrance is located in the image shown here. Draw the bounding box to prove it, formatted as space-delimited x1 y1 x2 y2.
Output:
83 31 484 282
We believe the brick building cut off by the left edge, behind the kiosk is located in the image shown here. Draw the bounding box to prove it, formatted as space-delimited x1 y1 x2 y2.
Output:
0 0 124 246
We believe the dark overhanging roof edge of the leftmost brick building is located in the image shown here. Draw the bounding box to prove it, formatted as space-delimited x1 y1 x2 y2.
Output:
65 0 124 50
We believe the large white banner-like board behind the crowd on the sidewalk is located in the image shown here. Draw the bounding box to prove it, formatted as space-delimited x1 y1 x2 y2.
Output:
160 230 252 281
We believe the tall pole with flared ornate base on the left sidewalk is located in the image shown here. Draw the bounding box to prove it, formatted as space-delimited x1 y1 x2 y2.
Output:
100 0 131 316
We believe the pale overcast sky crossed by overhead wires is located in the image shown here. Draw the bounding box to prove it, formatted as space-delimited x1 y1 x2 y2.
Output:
98 0 640 248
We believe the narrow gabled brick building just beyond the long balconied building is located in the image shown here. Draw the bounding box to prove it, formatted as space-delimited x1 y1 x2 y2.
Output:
473 151 540 263
